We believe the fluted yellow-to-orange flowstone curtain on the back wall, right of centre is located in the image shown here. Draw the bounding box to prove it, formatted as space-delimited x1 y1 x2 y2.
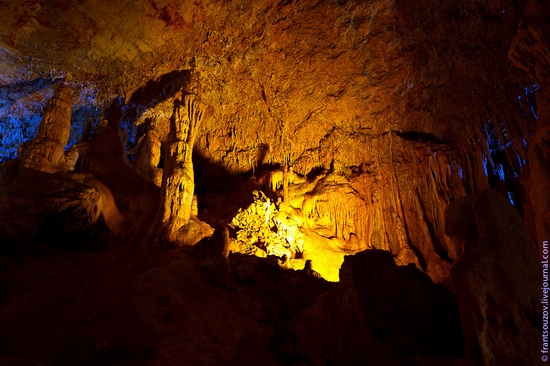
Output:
258 134 478 279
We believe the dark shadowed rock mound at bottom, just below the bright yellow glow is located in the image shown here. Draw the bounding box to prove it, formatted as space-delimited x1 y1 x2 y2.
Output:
293 250 464 365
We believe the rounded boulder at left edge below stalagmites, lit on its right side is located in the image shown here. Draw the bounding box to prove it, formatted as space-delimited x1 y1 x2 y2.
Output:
0 173 113 253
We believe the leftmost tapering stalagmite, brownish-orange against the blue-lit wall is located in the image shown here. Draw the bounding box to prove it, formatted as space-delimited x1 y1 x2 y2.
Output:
20 83 73 173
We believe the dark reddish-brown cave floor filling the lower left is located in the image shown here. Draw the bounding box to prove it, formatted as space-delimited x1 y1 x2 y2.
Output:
0 249 286 365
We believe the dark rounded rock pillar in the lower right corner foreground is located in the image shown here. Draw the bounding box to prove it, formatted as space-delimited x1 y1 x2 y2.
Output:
445 190 542 366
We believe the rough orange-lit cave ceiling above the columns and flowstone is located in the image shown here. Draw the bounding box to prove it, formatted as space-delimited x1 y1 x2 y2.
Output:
0 0 530 174
